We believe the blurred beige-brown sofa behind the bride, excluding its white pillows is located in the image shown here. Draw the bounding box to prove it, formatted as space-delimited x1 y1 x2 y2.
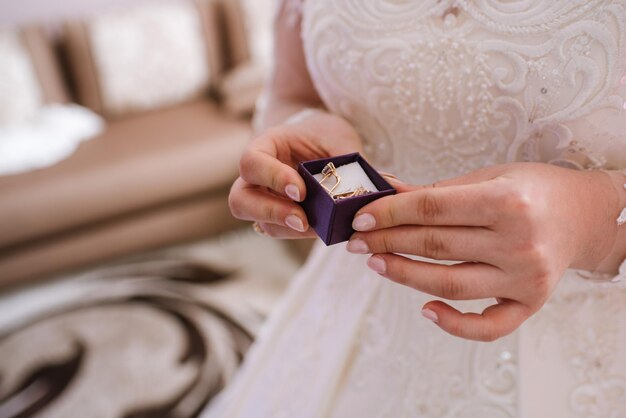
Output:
0 0 258 285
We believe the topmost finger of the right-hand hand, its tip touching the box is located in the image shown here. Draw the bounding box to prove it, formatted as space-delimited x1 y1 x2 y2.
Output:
352 183 498 231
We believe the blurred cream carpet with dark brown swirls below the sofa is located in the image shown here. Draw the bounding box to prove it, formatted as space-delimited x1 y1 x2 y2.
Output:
0 232 300 418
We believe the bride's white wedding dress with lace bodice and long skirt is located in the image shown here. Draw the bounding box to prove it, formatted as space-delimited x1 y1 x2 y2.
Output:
207 0 626 418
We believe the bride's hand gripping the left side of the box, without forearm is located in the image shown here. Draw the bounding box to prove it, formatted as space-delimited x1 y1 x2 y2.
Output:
228 110 362 239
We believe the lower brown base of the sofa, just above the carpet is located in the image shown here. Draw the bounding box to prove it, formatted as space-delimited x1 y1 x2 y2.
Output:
0 195 240 288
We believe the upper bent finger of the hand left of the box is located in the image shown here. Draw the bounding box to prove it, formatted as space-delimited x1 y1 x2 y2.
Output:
239 147 306 202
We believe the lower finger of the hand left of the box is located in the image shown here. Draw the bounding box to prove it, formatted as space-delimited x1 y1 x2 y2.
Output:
228 178 309 232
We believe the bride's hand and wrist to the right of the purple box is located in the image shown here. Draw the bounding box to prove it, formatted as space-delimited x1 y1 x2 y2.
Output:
348 163 621 341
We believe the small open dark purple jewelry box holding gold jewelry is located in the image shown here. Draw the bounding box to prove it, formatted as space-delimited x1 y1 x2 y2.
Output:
298 153 396 245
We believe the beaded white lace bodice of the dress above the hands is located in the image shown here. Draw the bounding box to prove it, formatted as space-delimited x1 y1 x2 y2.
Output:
300 0 626 182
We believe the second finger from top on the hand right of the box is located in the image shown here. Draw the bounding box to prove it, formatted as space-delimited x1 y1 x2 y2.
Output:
347 226 499 263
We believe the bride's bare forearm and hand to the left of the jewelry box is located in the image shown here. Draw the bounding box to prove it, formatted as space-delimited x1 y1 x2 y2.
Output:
229 4 362 239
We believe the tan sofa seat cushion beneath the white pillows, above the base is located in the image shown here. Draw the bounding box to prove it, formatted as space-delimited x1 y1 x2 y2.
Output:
0 101 250 248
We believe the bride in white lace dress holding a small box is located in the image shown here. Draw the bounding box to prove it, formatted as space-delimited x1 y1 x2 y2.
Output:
202 0 626 418
